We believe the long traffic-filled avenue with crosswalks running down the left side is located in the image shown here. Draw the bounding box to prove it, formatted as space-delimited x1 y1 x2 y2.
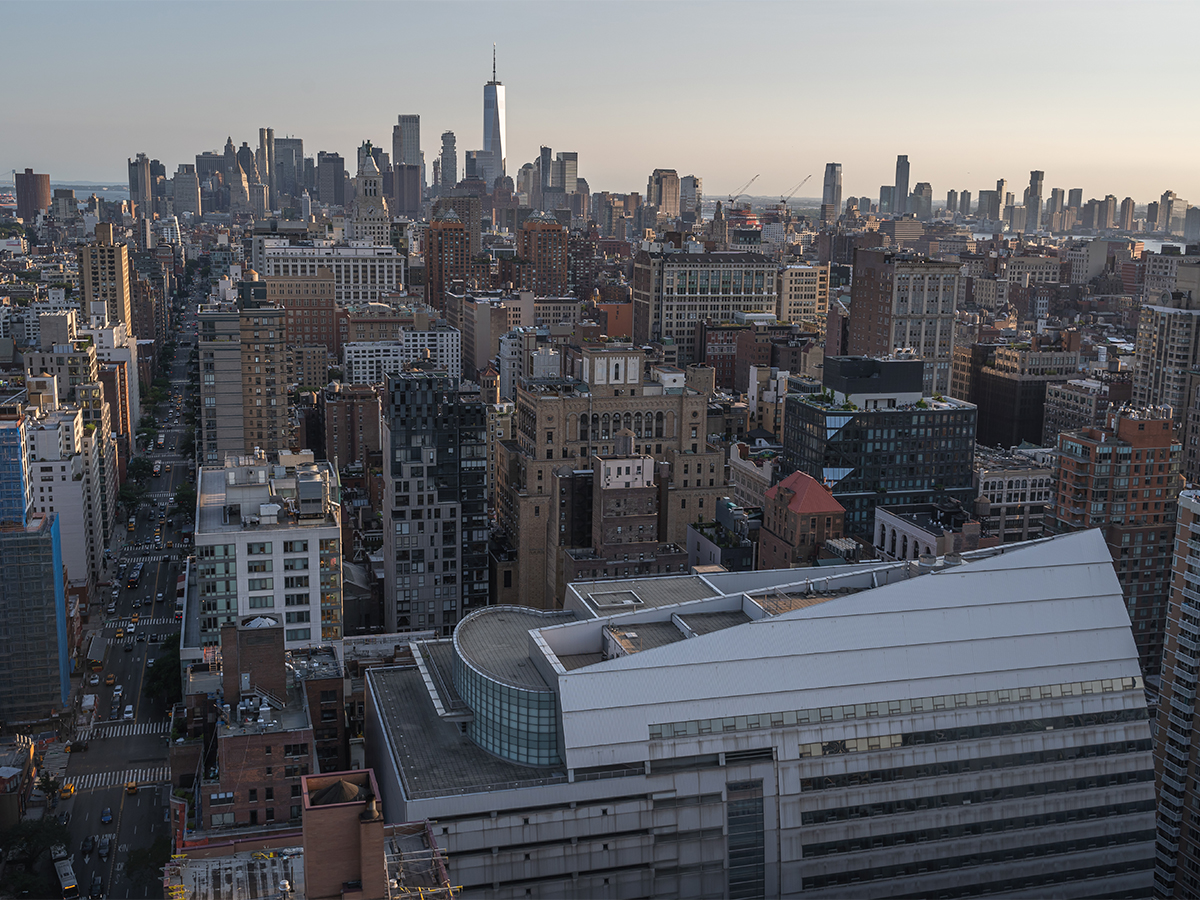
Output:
56 317 193 898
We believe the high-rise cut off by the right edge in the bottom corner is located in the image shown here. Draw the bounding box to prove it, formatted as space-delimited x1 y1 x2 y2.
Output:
1154 490 1200 900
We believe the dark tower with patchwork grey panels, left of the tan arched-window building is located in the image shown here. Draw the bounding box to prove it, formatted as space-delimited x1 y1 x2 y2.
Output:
382 368 488 636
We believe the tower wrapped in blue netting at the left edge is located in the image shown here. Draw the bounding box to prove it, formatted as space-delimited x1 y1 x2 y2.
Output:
0 410 66 726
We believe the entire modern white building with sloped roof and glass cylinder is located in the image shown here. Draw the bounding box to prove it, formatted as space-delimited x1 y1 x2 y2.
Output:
366 532 1154 898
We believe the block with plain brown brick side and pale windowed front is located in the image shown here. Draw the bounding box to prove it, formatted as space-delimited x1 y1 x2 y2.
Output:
848 250 959 395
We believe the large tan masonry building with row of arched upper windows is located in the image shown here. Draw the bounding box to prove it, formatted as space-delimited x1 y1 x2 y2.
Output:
492 343 725 608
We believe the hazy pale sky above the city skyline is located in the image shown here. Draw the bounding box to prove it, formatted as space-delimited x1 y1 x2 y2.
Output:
0 1 1200 203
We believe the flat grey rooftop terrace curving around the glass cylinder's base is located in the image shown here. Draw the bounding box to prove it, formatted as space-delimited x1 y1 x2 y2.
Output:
367 662 566 799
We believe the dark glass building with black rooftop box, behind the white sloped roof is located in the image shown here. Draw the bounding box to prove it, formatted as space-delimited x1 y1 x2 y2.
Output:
784 355 977 538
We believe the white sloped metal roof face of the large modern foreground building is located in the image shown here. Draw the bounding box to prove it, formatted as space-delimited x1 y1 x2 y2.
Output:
559 530 1140 764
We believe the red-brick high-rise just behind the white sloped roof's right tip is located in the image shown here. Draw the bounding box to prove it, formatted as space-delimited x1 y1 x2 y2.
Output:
1046 407 1183 679
